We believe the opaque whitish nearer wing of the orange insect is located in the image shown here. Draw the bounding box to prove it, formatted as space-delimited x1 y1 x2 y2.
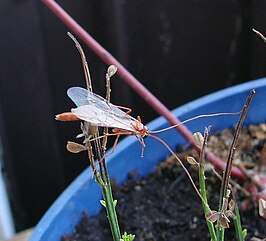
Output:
71 105 136 131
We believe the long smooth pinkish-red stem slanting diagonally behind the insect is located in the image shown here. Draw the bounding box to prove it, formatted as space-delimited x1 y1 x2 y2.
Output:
42 0 245 179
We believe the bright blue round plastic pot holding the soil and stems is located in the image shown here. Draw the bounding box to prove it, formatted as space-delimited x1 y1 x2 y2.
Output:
29 78 266 241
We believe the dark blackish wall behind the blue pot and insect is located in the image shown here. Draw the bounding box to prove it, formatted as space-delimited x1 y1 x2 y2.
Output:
0 0 266 230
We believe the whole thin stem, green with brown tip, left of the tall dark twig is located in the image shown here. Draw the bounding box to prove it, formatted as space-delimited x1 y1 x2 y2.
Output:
199 128 217 241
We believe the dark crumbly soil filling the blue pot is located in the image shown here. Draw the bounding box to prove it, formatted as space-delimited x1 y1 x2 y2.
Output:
62 125 266 241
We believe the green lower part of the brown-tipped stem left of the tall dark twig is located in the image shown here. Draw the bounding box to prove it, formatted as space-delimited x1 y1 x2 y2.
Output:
199 165 217 241
